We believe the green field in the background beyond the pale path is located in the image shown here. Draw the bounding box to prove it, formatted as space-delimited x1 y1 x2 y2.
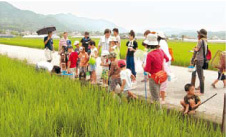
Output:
0 37 226 69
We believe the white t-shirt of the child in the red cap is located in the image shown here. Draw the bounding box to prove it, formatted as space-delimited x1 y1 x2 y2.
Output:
120 69 132 91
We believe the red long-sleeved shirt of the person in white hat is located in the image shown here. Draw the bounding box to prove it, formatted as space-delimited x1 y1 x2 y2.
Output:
144 49 169 74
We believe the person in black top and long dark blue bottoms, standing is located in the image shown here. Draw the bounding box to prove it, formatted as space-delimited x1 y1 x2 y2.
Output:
126 30 138 77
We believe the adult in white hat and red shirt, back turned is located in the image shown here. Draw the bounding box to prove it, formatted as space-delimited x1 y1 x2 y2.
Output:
144 33 169 102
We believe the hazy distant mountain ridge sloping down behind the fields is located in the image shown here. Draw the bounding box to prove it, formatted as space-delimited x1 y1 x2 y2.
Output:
0 1 127 32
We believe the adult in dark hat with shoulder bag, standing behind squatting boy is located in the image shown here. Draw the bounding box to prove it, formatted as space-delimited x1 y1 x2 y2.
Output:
191 29 207 95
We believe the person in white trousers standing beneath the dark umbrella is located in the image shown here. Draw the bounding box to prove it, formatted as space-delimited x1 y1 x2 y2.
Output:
44 31 54 62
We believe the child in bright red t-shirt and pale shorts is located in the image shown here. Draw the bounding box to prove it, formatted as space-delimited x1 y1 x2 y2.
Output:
68 46 78 78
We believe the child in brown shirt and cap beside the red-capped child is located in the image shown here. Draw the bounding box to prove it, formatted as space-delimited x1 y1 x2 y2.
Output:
109 52 122 92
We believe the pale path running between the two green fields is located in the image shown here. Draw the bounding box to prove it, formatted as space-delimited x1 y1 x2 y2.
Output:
0 44 225 122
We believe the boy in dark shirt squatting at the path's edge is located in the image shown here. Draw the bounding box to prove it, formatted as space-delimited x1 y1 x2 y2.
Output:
180 84 201 114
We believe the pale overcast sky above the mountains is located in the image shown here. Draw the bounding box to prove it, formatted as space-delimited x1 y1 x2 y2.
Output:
8 0 226 32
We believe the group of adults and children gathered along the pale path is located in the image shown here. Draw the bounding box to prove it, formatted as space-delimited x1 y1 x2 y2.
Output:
37 28 226 114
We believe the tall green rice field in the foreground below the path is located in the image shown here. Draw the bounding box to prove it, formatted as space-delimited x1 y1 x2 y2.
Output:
0 55 223 137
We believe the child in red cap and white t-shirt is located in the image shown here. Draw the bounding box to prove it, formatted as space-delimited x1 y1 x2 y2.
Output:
118 60 137 99
